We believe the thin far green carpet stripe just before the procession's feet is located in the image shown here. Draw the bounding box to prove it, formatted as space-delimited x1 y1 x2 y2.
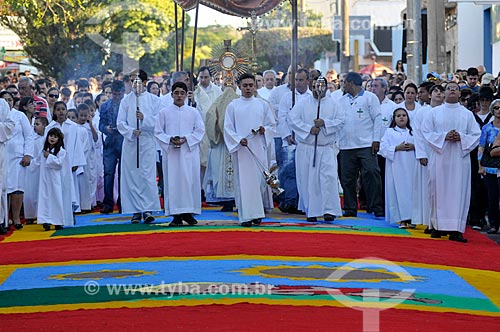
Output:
51 224 411 237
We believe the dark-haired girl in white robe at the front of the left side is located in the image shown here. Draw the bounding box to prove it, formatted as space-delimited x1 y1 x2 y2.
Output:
37 128 74 231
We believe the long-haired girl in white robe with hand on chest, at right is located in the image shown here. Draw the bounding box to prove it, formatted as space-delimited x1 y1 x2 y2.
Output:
380 107 417 228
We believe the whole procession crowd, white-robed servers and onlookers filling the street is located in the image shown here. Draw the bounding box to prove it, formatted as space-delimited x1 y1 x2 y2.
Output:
0 62 500 242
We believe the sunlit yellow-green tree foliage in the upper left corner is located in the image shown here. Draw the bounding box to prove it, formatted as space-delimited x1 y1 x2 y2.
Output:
0 0 179 80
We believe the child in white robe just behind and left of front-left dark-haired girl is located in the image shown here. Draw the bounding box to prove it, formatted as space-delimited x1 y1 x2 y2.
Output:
23 117 49 224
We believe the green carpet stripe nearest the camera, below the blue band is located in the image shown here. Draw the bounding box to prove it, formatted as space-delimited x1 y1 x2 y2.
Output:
0 286 500 313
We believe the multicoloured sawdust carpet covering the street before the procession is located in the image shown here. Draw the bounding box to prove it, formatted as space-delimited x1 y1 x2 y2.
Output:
0 208 500 332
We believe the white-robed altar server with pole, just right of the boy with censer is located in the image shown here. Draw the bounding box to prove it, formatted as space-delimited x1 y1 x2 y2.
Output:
287 77 345 223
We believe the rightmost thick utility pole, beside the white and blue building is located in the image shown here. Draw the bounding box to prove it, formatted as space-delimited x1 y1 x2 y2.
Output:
427 1 450 74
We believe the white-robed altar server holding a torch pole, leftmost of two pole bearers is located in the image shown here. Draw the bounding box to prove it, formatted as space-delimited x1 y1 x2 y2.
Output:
116 69 161 223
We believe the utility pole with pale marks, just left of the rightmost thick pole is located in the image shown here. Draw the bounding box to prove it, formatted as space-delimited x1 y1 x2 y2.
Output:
406 0 422 83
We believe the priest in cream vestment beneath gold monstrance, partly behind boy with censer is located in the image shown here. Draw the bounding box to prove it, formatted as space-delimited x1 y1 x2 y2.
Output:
203 78 240 212
